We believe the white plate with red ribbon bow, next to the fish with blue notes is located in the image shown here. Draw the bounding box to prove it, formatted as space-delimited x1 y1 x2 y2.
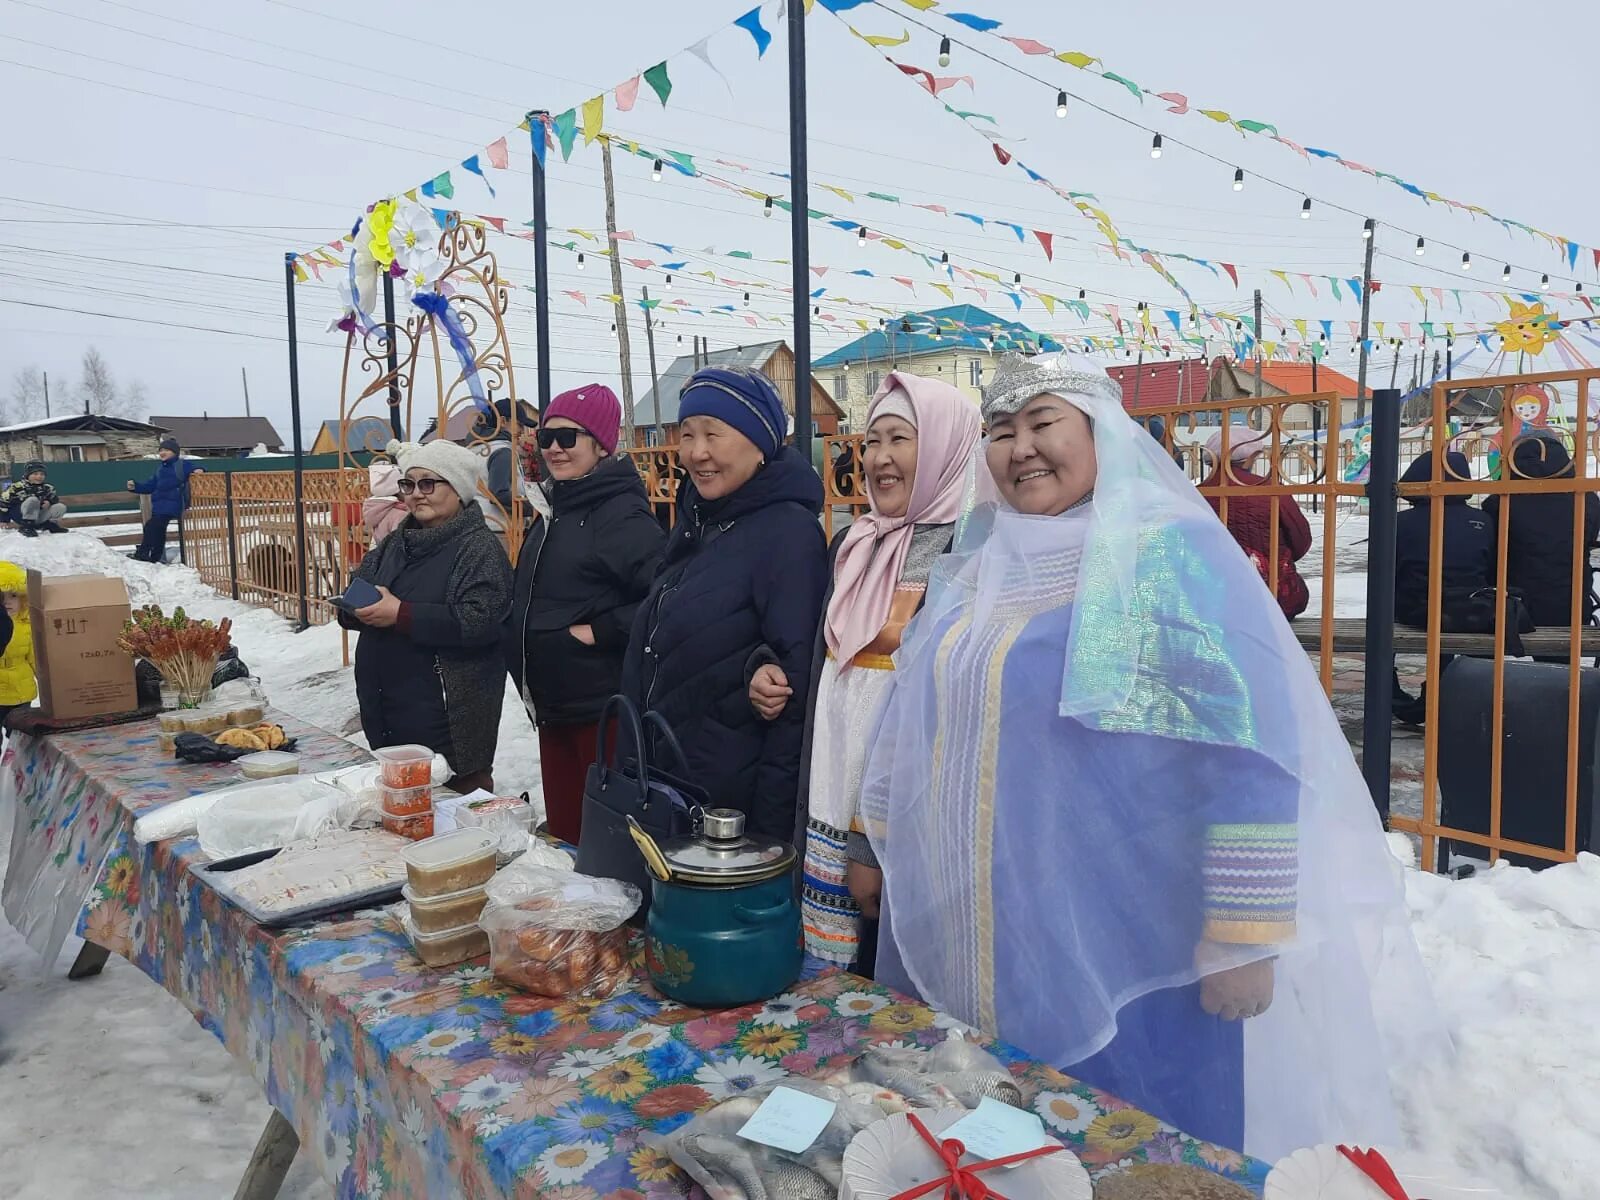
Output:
838 1109 1094 1200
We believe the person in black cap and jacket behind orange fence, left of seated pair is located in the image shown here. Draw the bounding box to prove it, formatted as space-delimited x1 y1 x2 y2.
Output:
1395 451 1494 629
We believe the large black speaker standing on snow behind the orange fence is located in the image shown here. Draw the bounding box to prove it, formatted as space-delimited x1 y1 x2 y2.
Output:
1438 658 1600 867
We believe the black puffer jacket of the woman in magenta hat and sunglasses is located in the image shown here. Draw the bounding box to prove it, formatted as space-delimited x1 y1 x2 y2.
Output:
506 454 667 725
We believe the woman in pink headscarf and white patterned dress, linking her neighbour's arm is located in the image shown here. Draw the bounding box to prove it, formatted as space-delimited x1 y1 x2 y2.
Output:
750 371 982 974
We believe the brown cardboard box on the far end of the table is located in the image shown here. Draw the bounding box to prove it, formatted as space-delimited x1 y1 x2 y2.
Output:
27 571 139 720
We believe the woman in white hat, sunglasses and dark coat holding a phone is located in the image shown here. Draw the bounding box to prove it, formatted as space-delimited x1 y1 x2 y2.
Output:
339 442 510 792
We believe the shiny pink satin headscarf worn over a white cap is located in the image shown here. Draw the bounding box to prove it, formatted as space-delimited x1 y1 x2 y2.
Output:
822 371 982 670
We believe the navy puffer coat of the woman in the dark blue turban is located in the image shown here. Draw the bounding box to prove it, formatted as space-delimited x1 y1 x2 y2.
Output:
622 448 827 842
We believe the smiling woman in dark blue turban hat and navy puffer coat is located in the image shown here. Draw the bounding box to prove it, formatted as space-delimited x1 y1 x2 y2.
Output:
622 366 827 842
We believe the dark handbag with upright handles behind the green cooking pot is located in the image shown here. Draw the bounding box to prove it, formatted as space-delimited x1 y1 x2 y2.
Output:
578 696 706 920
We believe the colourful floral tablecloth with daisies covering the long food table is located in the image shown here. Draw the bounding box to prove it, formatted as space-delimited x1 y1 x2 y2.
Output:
6 720 1267 1200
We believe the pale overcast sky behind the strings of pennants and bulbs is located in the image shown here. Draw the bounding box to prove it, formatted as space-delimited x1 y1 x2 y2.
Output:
0 0 1600 440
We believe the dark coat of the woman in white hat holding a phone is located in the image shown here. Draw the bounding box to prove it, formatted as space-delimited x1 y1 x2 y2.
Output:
339 504 510 774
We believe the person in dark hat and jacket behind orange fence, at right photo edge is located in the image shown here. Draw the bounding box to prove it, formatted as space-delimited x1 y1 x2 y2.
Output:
1483 437 1600 627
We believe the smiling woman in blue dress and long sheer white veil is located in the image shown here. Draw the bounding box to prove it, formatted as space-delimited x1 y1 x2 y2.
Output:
862 355 1437 1155
